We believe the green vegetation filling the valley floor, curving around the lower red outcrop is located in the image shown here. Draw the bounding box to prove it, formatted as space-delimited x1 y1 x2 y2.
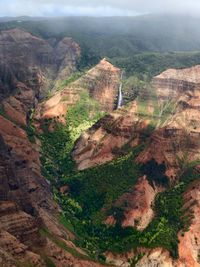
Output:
38 87 199 266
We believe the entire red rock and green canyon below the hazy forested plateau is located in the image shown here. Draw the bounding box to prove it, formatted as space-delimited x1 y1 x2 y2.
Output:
0 25 200 267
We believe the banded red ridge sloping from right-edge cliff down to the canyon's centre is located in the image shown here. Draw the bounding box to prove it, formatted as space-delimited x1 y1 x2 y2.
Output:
73 66 200 173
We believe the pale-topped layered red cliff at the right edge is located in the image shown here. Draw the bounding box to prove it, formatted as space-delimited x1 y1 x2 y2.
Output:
138 66 200 179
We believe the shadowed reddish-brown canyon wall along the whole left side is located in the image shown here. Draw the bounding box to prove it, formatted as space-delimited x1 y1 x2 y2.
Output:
0 29 106 267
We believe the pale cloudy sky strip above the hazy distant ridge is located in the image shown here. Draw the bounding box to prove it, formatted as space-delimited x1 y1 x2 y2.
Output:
0 0 200 17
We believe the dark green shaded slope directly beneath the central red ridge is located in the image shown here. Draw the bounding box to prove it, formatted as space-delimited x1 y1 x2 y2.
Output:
65 150 141 222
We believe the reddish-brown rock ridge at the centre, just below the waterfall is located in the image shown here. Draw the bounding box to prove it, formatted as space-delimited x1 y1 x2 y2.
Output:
72 102 148 170
